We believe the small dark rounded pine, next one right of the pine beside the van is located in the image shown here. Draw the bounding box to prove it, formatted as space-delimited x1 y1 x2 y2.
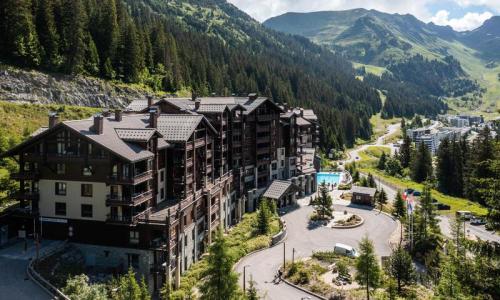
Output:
389 246 415 293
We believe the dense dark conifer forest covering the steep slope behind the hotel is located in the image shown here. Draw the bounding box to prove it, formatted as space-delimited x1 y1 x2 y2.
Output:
0 0 381 149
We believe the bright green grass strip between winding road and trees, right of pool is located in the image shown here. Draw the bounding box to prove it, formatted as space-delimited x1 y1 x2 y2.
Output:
359 146 487 215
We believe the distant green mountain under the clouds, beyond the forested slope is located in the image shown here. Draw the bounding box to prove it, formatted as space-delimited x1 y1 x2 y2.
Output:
264 9 500 115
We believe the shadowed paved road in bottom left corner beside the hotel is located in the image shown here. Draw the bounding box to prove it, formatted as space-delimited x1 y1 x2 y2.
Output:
0 241 58 300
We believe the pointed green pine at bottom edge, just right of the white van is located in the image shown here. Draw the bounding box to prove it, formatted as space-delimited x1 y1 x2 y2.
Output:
355 236 381 300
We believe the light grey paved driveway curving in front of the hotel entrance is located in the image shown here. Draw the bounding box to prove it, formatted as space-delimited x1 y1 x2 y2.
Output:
236 198 397 300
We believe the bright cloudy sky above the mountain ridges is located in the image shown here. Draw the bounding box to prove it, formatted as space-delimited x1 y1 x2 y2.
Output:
228 0 500 31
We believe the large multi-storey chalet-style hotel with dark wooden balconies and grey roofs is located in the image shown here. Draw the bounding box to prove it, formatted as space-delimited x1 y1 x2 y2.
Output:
2 94 319 290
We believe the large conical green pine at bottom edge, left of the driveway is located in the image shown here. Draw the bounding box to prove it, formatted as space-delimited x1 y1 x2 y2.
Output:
200 229 238 300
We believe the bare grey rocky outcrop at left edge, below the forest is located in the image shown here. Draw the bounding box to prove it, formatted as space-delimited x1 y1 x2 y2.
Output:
0 66 147 108
